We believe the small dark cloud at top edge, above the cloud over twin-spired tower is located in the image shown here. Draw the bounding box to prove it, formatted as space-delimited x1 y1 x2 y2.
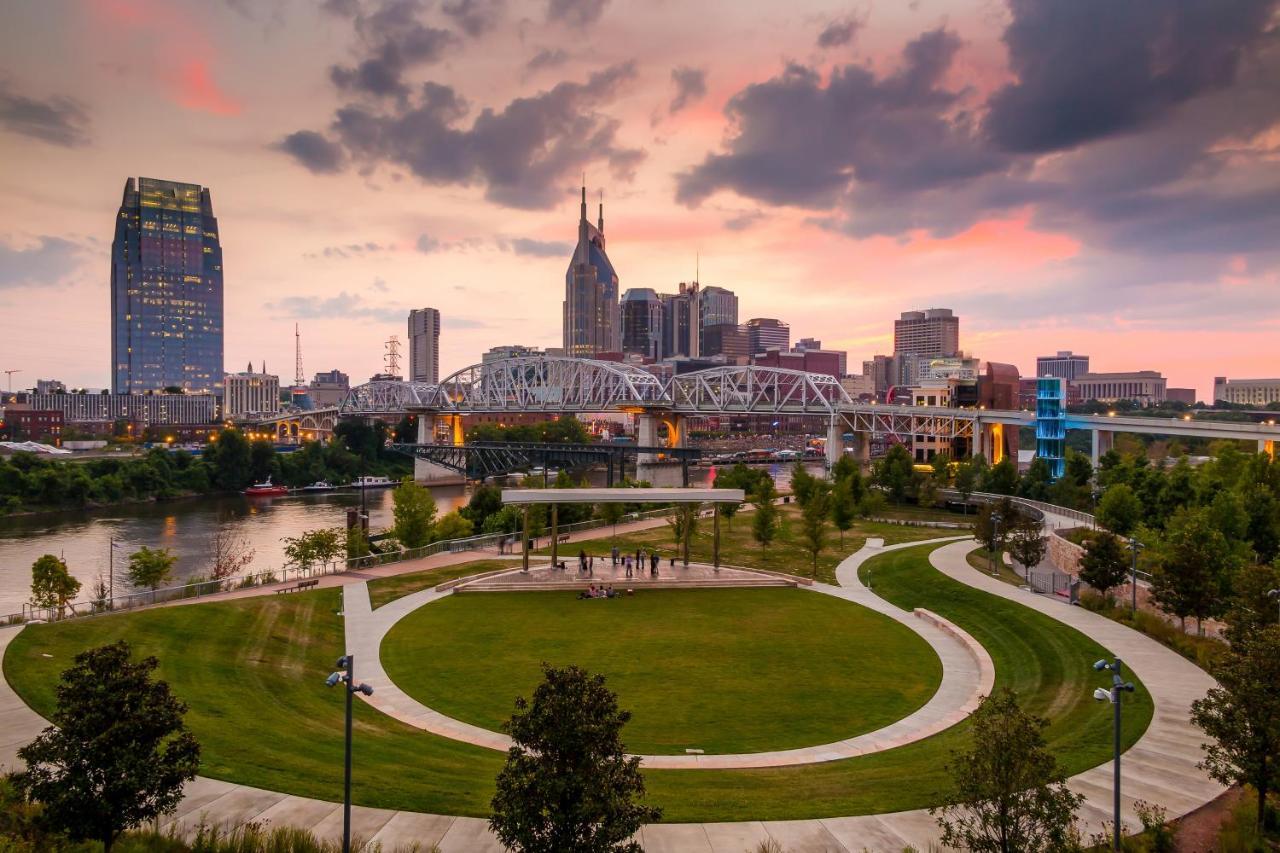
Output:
329 0 457 97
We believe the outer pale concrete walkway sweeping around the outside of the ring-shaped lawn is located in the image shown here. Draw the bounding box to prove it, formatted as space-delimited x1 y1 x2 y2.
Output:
0 539 1222 853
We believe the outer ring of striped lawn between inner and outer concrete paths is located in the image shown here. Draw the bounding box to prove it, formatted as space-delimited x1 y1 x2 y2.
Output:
4 535 1151 821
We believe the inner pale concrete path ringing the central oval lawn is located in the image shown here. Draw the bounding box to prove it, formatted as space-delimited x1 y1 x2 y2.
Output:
343 540 996 770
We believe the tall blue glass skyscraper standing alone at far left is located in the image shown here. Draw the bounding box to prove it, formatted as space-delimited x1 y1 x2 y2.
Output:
111 178 223 393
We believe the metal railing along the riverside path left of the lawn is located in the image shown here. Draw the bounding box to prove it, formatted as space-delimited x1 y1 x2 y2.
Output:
0 507 671 625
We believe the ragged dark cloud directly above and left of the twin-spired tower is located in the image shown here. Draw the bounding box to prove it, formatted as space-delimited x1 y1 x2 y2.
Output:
289 63 644 209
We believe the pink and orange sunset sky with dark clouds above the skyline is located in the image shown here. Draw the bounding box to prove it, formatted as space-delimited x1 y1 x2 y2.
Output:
0 0 1280 396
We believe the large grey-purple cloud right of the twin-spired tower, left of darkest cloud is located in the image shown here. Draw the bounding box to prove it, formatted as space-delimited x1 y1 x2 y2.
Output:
676 29 1007 207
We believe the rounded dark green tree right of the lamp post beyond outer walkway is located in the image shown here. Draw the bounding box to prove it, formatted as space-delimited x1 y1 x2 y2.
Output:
1151 507 1239 631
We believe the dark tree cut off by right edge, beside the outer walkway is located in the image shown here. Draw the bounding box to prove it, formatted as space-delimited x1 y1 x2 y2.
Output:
1192 625 1280 834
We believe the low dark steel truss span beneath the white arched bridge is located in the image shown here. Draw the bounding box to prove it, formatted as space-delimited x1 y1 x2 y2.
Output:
390 442 701 487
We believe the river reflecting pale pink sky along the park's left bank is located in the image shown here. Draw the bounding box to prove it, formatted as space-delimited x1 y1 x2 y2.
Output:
0 465 822 617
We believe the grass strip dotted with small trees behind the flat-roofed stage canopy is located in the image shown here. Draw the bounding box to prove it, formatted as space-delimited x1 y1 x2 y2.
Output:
538 503 961 584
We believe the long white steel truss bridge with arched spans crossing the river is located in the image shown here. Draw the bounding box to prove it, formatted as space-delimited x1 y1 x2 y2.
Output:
252 356 1280 452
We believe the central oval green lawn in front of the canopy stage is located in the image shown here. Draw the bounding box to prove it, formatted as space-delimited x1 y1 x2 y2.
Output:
383 589 942 754
